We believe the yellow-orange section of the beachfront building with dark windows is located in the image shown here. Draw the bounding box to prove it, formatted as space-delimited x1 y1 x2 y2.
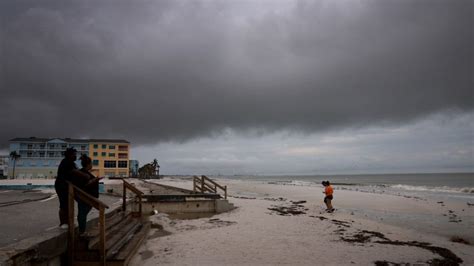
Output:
89 139 130 177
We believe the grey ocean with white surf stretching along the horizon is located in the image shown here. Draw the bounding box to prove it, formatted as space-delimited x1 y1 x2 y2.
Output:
221 173 474 201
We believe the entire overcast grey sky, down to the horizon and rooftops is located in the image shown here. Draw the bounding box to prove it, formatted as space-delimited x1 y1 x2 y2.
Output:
0 0 474 174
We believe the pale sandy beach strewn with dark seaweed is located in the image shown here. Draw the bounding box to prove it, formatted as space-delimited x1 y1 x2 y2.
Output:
131 178 474 265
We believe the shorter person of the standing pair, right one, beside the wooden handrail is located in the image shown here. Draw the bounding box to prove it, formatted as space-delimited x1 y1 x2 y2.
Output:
74 154 100 235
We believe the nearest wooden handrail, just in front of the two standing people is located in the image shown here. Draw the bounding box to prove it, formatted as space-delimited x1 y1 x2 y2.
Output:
66 181 109 265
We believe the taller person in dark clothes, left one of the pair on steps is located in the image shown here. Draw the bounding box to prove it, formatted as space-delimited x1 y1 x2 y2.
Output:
54 148 88 229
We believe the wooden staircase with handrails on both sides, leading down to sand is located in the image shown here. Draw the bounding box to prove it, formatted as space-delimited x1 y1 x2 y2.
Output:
68 180 150 266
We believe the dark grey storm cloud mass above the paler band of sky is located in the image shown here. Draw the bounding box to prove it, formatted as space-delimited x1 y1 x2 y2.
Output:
0 0 474 147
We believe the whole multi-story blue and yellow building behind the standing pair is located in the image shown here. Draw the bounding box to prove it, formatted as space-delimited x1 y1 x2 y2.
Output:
8 137 130 178
